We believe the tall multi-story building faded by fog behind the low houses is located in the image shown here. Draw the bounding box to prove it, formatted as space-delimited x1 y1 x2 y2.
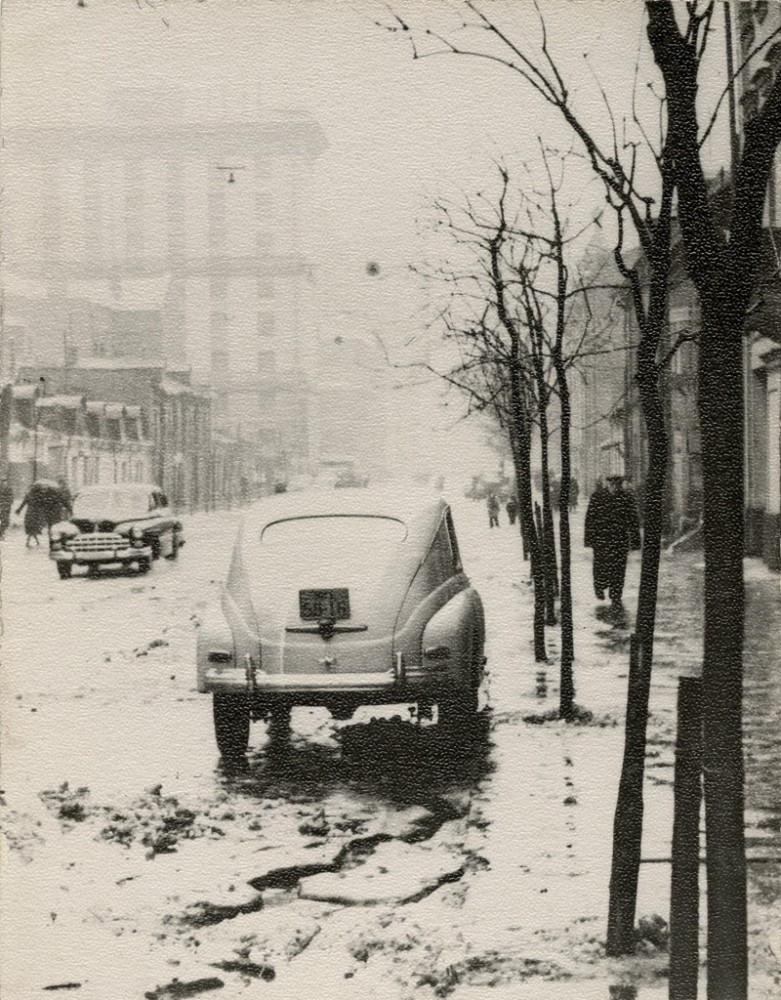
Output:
3 91 325 486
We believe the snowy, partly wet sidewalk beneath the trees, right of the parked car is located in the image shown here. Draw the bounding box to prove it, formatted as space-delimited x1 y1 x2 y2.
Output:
438 511 781 1000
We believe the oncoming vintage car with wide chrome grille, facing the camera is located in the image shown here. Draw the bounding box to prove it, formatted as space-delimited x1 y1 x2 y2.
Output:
49 483 184 579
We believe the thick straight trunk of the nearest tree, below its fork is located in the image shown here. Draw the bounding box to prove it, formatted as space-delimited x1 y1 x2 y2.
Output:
698 294 748 1000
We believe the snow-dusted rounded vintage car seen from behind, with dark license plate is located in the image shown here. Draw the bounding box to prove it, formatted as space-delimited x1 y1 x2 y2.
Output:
197 489 485 759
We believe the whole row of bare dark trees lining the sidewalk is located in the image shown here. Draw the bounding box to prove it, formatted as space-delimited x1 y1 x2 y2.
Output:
385 0 781 1000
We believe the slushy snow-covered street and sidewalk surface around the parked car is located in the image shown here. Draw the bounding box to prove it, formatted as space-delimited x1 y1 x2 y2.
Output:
2 501 781 1000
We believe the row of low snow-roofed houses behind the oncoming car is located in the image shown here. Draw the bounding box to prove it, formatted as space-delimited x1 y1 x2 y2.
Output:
0 359 280 511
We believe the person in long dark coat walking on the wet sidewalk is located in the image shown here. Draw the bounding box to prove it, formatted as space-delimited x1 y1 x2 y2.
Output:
584 476 640 606
